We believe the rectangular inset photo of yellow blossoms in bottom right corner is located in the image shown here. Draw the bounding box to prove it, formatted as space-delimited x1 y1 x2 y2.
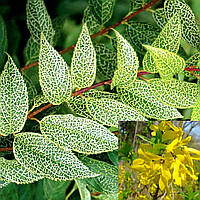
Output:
118 121 200 200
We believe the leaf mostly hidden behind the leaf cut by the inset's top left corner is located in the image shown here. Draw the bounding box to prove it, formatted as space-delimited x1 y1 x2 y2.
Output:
67 89 119 119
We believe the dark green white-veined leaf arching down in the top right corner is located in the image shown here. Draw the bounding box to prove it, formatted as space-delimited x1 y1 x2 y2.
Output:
164 0 200 48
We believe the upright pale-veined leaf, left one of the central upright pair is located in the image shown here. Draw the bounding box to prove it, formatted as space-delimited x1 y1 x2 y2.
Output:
39 34 72 105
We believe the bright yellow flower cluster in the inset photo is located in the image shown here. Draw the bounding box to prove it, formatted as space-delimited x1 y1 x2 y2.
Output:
131 121 200 199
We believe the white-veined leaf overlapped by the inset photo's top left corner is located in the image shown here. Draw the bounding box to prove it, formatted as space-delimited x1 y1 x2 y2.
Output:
86 98 146 127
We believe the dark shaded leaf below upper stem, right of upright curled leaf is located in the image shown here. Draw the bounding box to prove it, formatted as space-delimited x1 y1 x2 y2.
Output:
126 20 160 54
